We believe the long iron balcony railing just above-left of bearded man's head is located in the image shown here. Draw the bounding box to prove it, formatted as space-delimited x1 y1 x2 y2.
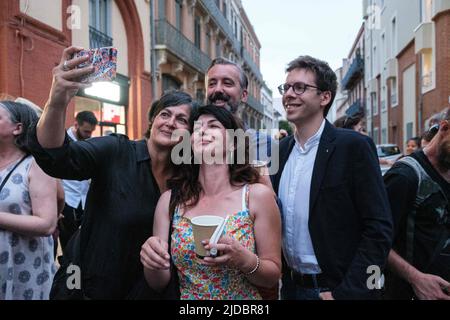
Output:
156 20 211 73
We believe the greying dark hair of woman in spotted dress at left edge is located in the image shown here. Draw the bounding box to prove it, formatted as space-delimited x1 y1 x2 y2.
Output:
0 100 38 154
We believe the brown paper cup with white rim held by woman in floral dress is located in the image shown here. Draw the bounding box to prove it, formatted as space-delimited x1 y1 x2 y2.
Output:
191 216 223 259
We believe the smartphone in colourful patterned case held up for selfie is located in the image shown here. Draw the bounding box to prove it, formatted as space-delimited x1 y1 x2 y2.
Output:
74 47 117 83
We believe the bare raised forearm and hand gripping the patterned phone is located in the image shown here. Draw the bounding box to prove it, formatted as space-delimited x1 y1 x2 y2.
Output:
37 47 93 148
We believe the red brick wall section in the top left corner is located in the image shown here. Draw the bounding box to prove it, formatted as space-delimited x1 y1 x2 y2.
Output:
0 0 71 124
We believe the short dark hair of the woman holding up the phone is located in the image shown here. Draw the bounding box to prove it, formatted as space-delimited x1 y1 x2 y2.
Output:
144 90 195 139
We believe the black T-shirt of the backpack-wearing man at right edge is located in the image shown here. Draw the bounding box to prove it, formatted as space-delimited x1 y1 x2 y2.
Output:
384 151 450 271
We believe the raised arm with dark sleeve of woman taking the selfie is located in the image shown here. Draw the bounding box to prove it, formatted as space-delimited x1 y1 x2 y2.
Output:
27 47 120 180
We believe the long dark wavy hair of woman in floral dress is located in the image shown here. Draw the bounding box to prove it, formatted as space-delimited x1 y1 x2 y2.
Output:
168 105 259 213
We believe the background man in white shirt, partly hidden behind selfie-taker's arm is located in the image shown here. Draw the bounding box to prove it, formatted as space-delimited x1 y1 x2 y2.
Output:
58 111 98 251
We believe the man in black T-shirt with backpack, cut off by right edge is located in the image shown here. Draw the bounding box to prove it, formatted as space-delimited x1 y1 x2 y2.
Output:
384 108 450 300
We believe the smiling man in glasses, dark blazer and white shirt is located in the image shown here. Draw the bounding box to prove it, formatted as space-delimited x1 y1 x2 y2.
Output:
271 56 393 299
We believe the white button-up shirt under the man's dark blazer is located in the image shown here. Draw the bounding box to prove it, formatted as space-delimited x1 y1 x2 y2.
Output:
279 120 325 274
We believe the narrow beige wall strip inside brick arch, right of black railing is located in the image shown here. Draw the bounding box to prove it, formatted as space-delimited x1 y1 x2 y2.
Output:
111 1 128 76
